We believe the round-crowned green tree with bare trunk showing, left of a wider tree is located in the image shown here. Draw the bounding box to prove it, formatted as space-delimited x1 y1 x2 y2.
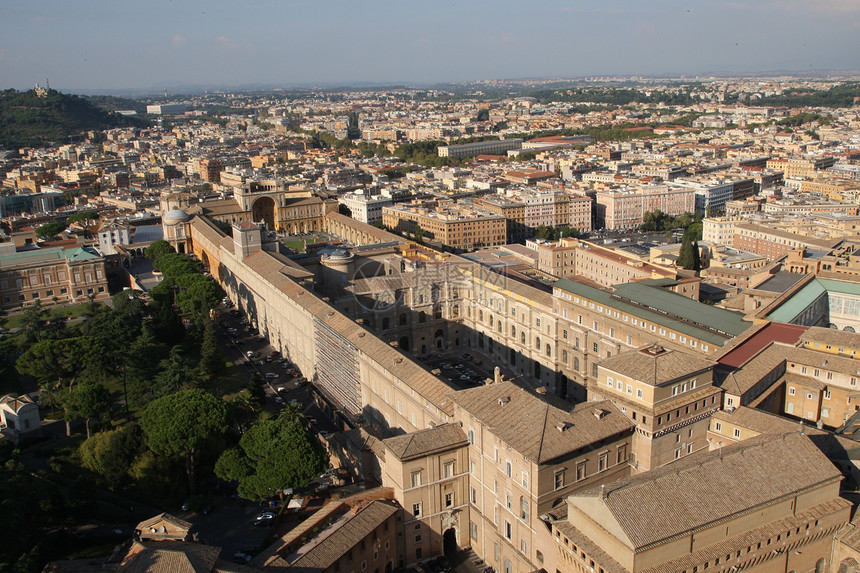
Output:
140 389 227 493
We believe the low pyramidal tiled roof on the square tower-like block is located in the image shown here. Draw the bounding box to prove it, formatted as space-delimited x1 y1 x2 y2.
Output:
600 345 717 386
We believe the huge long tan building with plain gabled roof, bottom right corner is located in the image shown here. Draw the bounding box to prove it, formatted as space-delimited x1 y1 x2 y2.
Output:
548 433 851 573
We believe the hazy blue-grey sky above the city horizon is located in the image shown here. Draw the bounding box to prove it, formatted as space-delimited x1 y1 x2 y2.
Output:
0 0 860 93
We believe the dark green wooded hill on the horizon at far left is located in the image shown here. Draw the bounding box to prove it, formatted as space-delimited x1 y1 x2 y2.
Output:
0 89 147 149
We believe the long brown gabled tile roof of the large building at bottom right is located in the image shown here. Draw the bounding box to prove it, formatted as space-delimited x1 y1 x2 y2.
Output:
568 432 842 549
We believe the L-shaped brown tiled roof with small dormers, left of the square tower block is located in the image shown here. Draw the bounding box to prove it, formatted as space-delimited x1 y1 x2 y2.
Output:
451 382 634 464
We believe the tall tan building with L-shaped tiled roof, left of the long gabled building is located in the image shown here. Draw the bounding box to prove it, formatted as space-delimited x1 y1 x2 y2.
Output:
452 382 633 573
